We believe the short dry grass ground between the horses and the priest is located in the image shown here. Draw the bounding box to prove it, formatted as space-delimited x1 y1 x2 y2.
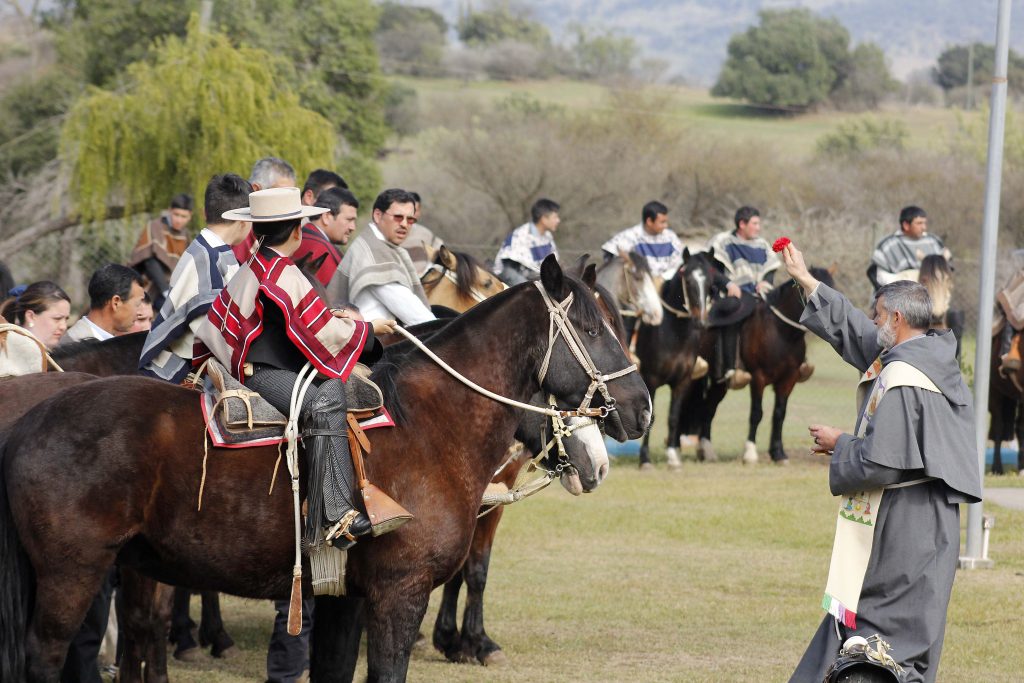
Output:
163 344 1024 683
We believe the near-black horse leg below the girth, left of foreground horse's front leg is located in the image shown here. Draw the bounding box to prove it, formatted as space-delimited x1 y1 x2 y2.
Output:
309 595 366 683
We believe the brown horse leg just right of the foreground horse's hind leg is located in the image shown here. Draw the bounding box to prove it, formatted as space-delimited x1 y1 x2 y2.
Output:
118 567 173 683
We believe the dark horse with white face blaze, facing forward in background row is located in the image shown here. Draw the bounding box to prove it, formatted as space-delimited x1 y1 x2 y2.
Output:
636 250 715 469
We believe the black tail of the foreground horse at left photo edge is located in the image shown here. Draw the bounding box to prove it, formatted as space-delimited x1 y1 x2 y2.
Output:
0 434 35 683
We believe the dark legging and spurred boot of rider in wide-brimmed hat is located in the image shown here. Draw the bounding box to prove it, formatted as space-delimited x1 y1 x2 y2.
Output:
302 379 372 550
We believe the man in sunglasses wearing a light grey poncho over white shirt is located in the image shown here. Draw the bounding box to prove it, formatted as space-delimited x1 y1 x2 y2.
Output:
327 188 435 326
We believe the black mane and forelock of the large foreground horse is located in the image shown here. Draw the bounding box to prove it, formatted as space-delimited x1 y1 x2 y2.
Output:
370 273 602 425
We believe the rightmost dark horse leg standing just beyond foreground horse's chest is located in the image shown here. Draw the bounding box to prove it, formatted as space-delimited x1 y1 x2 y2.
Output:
462 509 506 667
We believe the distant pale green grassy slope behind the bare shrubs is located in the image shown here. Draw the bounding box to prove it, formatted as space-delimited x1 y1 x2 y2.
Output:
399 78 956 155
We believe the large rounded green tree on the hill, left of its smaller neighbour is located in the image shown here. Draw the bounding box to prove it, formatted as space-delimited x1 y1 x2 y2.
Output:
712 9 850 110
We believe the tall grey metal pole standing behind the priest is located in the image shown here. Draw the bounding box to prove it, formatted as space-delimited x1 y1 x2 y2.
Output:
961 0 1010 568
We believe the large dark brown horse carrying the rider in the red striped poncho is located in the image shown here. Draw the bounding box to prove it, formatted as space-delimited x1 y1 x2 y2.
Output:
0 259 650 681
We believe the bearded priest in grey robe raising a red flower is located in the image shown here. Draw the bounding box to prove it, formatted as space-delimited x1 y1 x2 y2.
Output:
782 244 982 683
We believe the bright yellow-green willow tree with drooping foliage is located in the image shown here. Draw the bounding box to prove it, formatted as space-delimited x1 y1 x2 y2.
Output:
60 16 336 221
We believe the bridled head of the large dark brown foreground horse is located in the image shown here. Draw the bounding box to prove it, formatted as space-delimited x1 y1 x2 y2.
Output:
536 256 652 441
